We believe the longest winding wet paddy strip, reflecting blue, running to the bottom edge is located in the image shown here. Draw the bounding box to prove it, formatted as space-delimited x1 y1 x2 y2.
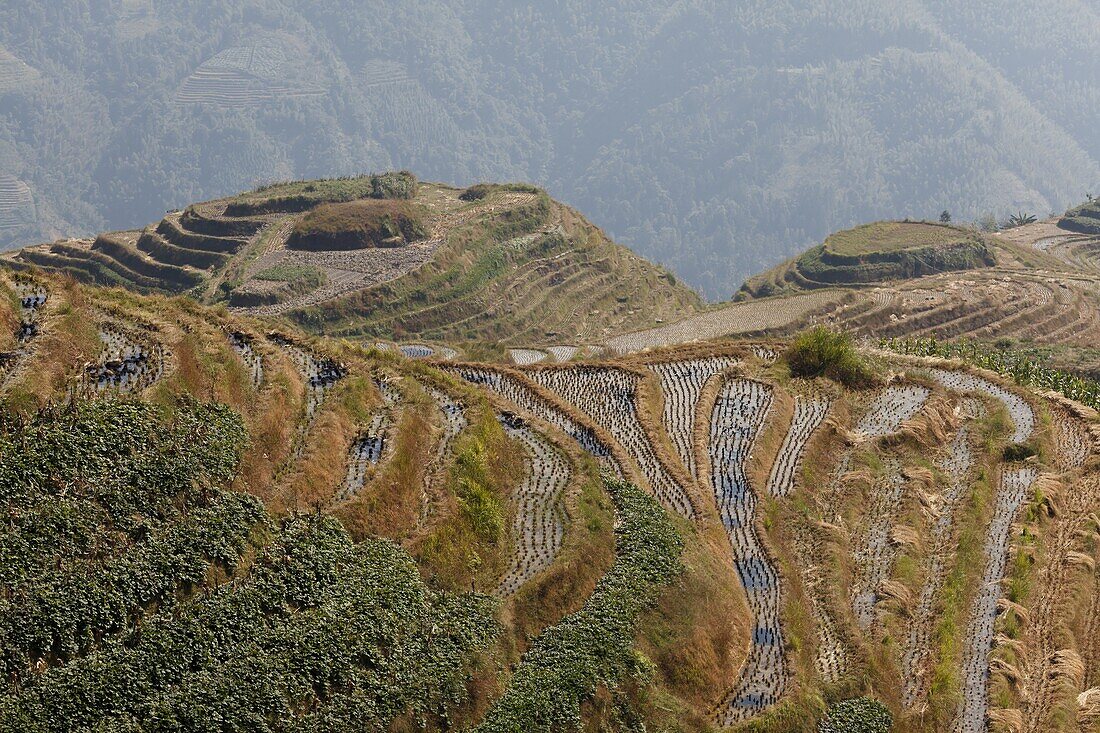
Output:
710 380 790 725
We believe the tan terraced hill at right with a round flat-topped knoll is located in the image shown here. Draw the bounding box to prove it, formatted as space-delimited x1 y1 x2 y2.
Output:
594 203 1100 375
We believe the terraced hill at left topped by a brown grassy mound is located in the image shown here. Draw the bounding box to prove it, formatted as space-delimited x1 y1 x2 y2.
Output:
0 173 701 348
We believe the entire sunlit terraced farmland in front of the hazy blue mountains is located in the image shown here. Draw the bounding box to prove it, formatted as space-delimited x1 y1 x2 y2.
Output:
0 172 1100 733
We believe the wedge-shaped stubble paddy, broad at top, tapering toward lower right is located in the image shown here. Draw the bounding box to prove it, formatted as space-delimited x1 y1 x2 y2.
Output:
529 367 695 517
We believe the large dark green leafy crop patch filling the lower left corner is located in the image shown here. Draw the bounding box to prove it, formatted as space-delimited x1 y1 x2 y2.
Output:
0 401 497 733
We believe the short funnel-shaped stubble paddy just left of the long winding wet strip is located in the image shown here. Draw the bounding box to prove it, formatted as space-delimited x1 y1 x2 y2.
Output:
649 357 737 479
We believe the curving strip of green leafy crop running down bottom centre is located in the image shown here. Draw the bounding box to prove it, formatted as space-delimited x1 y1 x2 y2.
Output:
476 480 683 733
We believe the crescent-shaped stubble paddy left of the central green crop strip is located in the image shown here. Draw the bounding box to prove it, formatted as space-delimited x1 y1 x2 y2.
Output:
496 414 571 597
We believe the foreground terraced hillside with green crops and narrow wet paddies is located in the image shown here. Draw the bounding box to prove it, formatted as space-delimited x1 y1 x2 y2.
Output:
0 268 1100 733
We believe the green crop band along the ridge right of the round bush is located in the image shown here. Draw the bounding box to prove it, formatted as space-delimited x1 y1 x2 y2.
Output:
879 338 1100 409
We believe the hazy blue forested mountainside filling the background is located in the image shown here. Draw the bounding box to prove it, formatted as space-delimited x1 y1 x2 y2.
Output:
0 0 1100 298
